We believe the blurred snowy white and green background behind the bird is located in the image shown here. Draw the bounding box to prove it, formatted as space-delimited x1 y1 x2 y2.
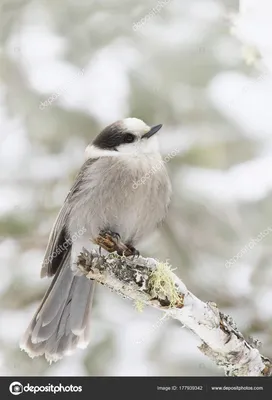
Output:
0 0 272 376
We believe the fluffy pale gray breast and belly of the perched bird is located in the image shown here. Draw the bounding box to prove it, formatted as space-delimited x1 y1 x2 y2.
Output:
69 154 171 245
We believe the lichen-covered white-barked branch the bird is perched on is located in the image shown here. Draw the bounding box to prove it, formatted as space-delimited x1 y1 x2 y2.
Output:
78 249 272 376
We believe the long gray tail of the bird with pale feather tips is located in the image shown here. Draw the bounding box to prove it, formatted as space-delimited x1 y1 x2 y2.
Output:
20 257 94 362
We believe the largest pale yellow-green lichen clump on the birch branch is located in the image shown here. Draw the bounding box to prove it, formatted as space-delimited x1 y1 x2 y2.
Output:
149 261 182 307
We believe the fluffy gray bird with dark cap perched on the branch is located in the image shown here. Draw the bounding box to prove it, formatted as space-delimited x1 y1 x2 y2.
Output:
20 118 172 363
